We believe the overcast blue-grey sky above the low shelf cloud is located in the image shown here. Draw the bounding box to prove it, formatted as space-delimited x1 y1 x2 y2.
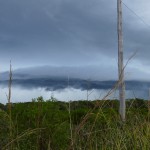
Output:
0 0 150 80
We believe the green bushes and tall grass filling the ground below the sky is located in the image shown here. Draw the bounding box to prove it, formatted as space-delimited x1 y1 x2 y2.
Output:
0 97 150 150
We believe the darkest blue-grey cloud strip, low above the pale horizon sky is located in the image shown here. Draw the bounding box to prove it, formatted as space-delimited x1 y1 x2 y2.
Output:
0 77 150 92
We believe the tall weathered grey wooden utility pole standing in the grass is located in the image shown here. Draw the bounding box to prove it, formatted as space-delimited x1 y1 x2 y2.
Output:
117 0 126 121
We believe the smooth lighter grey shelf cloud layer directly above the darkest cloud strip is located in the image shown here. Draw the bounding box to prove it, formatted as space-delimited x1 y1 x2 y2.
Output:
0 64 149 82
